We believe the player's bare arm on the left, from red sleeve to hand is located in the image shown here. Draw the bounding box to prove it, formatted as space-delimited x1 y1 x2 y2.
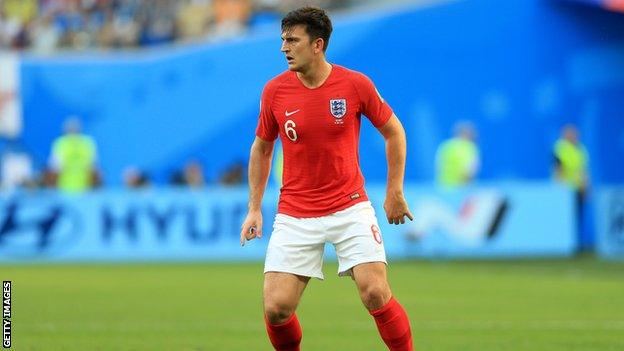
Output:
240 136 275 245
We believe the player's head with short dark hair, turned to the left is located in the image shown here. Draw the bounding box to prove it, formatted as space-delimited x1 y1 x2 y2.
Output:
281 7 332 71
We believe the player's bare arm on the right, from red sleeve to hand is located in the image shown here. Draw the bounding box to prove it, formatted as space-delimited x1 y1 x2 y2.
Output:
378 114 414 224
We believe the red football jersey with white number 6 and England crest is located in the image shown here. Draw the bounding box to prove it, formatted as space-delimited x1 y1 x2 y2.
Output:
256 65 392 218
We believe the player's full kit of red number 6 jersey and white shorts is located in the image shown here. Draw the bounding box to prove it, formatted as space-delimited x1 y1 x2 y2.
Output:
256 65 393 278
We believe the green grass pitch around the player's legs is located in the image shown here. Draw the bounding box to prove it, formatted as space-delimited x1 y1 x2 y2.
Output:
0 258 624 351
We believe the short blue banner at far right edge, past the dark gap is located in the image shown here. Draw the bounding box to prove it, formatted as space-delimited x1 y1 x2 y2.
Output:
596 187 624 259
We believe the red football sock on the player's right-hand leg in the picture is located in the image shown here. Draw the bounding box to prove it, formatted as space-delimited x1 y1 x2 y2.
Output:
370 297 414 351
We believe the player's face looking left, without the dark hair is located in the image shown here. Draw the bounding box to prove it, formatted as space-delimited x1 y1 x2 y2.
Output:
281 25 322 72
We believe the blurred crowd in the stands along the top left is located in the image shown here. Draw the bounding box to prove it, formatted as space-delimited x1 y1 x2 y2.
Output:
0 0 356 53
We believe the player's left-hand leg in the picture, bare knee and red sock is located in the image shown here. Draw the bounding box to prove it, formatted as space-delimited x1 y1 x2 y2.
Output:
263 272 310 351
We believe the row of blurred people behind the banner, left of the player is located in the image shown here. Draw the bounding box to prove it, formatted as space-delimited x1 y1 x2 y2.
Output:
0 116 246 193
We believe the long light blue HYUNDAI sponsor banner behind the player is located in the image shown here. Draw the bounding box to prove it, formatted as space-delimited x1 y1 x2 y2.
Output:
0 184 576 262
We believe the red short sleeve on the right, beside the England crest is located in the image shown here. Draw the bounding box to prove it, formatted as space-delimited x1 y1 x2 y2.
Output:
355 73 393 128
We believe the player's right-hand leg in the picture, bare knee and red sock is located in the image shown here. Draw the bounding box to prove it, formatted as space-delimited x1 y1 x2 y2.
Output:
352 262 414 351
